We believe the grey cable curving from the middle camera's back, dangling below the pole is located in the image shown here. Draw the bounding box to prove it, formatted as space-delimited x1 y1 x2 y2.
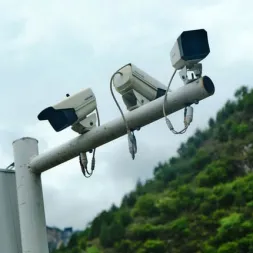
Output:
110 69 137 160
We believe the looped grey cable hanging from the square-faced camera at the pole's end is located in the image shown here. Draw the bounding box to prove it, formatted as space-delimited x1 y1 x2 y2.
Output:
163 69 193 134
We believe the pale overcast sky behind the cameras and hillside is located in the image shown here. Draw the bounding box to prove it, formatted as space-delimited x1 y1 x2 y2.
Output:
0 0 253 229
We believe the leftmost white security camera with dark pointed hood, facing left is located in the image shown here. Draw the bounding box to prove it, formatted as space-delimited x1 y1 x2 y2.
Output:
38 88 97 134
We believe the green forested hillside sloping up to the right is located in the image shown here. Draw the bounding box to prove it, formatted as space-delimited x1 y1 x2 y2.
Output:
55 87 253 253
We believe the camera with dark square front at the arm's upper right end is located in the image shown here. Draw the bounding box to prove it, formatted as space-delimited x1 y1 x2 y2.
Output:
170 29 210 70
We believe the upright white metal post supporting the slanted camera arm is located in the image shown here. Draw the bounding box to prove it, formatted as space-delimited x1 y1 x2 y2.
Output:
13 138 49 253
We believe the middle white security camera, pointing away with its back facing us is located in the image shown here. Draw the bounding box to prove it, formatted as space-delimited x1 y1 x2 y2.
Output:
113 63 166 111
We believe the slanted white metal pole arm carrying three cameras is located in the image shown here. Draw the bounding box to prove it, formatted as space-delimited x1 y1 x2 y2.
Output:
29 77 214 173
